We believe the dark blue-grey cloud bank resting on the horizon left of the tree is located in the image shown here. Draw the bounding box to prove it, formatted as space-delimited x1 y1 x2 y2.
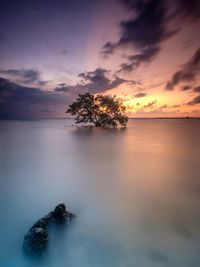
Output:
0 78 70 119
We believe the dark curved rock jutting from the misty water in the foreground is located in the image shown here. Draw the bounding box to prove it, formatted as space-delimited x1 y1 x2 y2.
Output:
23 203 76 254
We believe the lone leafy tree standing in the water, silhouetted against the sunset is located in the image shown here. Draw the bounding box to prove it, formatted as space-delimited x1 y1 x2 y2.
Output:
66 93 128 127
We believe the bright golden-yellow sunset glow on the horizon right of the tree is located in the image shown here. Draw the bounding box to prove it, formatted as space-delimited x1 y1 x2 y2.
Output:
109 84 200 117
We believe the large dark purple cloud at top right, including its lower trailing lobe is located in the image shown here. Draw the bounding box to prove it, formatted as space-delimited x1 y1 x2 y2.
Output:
102 0 176 72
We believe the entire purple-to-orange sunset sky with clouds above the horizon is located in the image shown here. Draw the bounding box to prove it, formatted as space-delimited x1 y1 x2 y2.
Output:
0 0 200 119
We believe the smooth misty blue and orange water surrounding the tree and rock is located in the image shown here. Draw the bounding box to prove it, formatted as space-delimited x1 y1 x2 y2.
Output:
0 119 200 267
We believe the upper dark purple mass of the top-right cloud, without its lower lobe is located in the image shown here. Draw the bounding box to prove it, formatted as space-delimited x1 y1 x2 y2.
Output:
103 0 174 54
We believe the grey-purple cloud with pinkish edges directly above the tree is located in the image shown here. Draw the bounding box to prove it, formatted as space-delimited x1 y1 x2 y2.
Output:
54 68 136 94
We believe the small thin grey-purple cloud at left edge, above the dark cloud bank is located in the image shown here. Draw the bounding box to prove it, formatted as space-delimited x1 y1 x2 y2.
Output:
0 69 47 85
